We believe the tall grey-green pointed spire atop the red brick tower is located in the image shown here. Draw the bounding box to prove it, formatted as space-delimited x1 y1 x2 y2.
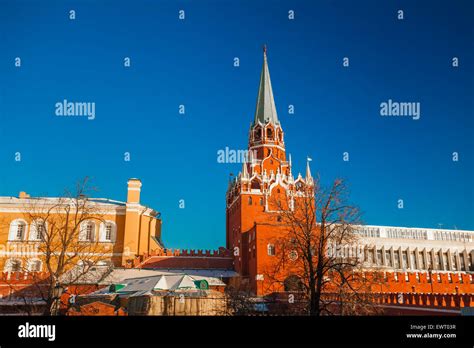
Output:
254 45 280 124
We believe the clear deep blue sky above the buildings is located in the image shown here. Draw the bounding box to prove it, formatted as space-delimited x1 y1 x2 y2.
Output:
0 0 474 248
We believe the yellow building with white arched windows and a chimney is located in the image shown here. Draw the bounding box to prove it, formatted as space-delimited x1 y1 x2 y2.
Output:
0 179 162 272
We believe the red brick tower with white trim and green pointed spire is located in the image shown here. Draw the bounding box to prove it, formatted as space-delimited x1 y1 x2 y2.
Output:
226 48 313 294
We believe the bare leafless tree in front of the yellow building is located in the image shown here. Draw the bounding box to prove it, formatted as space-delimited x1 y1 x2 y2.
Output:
4 178 111 315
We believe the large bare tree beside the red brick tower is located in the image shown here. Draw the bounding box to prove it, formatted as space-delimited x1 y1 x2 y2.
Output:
265 177 380 316
